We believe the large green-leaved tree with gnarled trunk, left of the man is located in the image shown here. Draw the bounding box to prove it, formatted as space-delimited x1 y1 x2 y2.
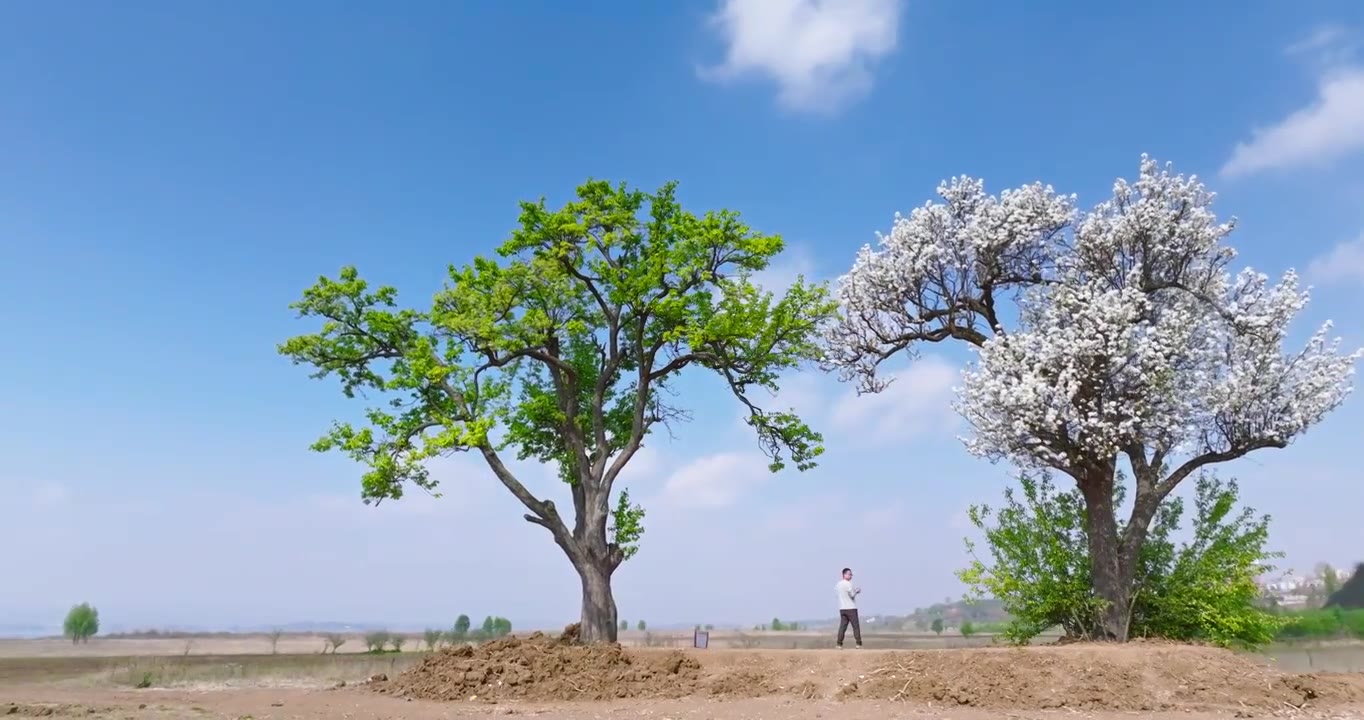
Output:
280 181 835 642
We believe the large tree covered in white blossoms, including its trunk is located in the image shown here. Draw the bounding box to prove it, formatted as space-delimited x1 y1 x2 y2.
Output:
827 155 1360 641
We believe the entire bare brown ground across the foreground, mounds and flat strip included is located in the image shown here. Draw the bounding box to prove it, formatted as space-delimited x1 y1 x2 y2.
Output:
8 634 1364 720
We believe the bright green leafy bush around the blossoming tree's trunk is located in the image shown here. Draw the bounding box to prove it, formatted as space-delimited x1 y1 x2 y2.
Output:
959 473 1284 646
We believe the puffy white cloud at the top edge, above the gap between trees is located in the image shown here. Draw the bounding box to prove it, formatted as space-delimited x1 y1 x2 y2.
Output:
701 0 904 112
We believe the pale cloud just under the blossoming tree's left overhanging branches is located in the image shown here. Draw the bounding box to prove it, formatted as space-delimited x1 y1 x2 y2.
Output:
832 356 960 445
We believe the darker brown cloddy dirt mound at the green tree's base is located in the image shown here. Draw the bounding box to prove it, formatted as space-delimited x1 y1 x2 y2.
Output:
370 625 701 702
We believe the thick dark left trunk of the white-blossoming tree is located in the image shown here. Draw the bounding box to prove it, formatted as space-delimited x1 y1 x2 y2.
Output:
1080 464 1135 642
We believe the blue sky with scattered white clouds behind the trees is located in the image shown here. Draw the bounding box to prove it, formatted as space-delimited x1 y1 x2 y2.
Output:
0 0 1364 626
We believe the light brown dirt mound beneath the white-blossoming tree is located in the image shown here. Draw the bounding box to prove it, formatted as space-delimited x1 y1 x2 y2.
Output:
836 644 1364 712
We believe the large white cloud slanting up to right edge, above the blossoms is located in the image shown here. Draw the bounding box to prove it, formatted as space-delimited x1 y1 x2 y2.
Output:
1222 67 1364 177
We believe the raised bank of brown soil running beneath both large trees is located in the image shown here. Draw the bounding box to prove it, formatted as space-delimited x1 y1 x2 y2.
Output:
370 626 1364 712
